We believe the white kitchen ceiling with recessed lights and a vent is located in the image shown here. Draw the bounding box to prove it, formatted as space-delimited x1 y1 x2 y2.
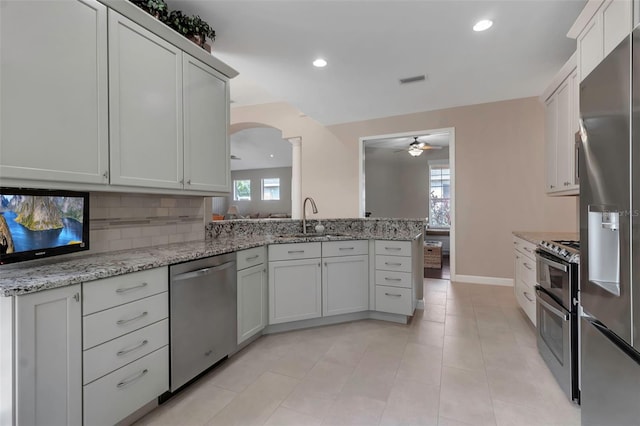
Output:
169 0 585 125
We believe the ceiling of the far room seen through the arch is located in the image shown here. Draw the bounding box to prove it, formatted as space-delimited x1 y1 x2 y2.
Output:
229 127 292 170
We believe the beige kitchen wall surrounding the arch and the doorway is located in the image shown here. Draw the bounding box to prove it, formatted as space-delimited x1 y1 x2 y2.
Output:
231 98 578 278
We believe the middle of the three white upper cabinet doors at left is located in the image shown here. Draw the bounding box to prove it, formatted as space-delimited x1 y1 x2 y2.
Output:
109 10 184 189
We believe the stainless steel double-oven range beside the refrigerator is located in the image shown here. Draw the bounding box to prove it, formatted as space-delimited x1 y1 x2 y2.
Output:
536 241 580 403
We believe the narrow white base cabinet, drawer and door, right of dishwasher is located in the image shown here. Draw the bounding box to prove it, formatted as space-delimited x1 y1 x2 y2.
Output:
237 247 269 344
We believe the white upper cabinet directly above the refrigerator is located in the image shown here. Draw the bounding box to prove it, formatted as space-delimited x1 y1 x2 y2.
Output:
567 0 633 81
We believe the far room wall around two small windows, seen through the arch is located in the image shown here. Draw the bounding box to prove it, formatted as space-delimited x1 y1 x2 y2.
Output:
225 167 291 216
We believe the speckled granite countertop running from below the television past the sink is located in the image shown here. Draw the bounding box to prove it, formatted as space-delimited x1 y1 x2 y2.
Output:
0 232 421 296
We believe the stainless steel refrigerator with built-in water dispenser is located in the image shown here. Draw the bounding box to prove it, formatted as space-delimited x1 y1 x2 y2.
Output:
579 29 640 426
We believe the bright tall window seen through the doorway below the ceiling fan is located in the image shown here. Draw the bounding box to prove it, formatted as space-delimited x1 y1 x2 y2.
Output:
429 161 451 228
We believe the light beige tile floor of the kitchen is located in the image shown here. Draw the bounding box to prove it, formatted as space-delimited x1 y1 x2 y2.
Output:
136 279 580 426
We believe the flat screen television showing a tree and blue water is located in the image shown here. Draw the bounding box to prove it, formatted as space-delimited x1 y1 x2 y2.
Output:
0 188 89 265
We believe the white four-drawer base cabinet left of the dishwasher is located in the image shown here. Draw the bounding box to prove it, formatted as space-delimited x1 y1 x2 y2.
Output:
82 267 169 426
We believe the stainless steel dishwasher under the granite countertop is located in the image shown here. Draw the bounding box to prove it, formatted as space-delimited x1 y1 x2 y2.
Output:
169 253 237 392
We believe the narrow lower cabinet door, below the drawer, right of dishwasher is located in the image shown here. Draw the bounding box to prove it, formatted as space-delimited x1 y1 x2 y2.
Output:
238 265 268 344
